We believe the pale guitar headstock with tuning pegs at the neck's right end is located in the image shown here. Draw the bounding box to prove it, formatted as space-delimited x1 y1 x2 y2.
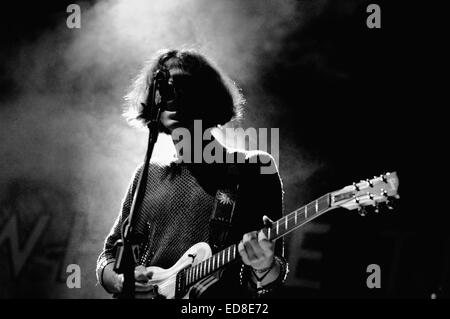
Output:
331 172 400 215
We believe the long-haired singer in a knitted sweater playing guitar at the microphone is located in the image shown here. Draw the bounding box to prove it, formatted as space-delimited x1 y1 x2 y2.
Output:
97 50 288 298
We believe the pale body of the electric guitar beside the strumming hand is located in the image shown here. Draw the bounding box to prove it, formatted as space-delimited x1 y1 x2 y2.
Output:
146 242 212 299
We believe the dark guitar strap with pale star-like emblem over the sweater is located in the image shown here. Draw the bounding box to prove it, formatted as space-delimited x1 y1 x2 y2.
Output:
209 165 239 253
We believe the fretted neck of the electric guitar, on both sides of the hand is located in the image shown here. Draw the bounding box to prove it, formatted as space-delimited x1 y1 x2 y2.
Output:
184 193 333 286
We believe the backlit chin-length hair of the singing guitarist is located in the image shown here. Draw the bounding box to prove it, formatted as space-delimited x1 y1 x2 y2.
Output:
123 50 245 127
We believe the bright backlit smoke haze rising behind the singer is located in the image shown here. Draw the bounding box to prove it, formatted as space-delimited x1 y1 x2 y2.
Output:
0 0 324 298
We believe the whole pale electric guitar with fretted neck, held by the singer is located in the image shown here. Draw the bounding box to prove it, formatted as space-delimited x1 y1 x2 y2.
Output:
132 172 399 299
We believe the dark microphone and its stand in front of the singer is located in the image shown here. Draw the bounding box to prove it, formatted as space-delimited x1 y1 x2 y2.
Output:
114 70 166 299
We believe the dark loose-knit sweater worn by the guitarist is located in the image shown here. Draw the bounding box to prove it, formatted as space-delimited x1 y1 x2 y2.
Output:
97 146 283 298
